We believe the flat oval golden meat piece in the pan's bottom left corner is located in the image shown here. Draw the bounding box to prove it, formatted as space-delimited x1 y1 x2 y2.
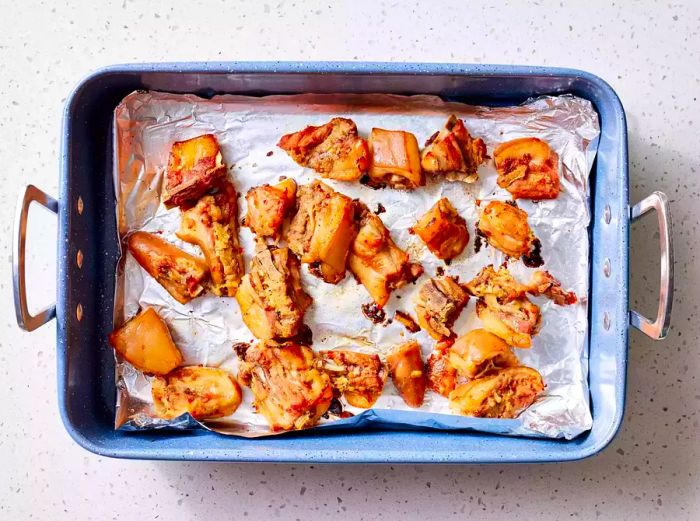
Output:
151 366 242 420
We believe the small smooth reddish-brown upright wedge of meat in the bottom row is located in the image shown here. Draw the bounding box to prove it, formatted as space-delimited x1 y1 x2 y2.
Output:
386 341 426 408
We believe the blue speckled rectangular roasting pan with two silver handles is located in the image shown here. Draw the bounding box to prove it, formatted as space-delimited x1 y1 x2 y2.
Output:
14 62 673 463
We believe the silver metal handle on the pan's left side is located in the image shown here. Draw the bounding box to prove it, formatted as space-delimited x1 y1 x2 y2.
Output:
12 185 58 331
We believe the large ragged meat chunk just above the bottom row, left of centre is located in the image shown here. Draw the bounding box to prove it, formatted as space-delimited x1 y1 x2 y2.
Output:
236 248 311 339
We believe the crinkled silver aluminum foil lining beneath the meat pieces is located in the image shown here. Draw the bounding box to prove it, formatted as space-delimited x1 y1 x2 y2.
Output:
114 92 599 438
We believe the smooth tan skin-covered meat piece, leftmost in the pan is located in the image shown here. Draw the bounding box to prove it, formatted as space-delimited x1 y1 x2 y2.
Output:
109 308 182 375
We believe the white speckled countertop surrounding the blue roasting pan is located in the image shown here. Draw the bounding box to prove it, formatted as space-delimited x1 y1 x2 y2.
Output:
0 0 700 520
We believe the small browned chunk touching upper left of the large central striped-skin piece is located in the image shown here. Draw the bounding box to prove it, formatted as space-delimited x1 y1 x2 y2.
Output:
245 179 297 241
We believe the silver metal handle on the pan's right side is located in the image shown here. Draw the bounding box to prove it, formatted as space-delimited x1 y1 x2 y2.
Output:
630 192 673 340
